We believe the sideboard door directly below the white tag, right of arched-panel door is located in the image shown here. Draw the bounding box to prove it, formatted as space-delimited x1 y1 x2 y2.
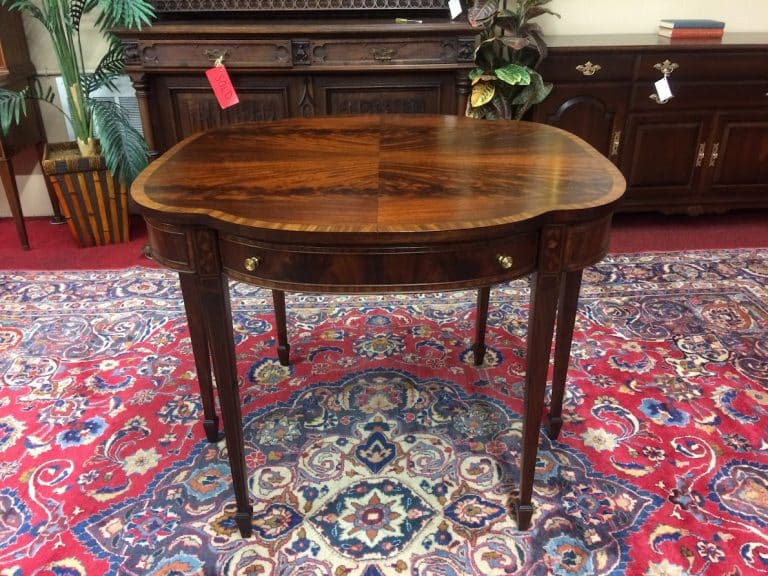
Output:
620 112 712 212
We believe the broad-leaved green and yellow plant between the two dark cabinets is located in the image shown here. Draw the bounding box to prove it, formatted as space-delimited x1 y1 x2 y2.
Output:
466 0 560 120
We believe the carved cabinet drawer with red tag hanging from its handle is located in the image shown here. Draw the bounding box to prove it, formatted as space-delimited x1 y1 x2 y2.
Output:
136 40 291 69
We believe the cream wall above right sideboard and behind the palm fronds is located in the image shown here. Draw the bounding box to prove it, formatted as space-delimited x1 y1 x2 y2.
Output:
0 0 768 217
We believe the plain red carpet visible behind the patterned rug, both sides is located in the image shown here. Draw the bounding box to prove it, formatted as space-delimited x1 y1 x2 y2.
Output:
0 210 768 270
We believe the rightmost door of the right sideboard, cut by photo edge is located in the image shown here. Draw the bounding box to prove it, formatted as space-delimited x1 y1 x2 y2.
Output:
704 111 768 205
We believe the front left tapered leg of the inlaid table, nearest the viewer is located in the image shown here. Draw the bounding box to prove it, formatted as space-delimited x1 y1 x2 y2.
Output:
197 274 253 538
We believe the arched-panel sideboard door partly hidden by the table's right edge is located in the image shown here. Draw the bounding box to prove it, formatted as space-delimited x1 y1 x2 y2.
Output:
533 84 629 163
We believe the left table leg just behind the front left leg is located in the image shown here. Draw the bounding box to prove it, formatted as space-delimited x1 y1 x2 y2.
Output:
179 273 223 442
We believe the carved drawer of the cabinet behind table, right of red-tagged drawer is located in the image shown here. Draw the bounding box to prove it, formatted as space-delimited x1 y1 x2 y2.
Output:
310 38 457 68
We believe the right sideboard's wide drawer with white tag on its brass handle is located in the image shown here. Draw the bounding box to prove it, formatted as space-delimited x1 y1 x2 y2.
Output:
637 49 768 82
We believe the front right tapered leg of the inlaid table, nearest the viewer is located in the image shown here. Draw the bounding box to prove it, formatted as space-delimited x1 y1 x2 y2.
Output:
517 272 560 530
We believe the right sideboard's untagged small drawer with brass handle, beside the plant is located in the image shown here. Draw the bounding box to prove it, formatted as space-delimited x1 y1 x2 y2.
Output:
540 52 634 83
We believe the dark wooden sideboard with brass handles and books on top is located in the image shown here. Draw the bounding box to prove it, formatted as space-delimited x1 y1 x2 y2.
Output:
533 33 768 214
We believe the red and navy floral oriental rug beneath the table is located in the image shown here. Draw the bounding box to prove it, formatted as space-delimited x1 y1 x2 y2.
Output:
0 250 768 576
